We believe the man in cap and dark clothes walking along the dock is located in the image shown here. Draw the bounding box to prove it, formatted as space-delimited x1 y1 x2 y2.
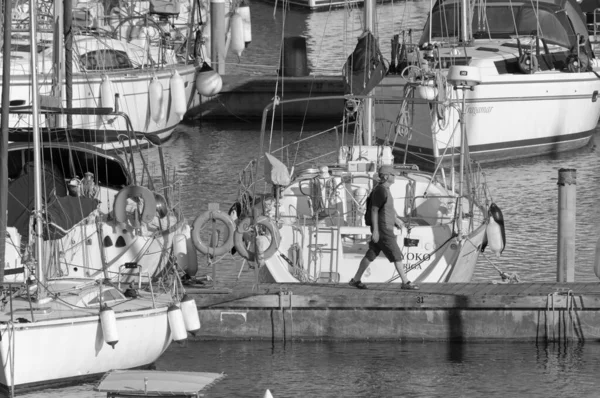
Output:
350 165 419 290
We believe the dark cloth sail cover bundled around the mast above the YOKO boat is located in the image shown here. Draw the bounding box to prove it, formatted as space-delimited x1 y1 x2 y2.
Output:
342 31 387 95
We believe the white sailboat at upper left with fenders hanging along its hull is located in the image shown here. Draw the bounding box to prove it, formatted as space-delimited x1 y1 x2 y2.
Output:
0 0 210 150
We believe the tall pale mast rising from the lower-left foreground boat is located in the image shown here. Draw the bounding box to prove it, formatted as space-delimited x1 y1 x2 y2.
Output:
29 1 46 300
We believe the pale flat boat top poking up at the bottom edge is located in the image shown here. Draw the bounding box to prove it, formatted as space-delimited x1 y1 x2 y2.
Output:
94 370 226 398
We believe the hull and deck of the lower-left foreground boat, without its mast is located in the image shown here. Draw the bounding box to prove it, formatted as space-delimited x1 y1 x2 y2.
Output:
0 277 174 392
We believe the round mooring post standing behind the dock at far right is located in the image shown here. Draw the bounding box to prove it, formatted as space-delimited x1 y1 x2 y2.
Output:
556 169 577 282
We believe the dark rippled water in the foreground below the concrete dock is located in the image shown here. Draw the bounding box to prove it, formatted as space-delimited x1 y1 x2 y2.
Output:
24 341 600 398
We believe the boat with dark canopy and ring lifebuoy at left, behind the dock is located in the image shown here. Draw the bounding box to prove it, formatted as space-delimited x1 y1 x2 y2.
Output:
5 107 197 283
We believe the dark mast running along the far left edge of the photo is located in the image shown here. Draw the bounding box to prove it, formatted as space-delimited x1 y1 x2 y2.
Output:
0 1 12 282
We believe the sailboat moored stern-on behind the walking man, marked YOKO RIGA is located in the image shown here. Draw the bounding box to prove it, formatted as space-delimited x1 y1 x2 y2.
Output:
204 2 500 284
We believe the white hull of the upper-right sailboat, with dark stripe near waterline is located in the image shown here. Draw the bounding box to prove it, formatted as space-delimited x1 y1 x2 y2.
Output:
375 71 600 163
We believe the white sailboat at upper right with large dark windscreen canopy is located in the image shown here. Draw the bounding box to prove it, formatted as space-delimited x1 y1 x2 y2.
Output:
375 0 600 169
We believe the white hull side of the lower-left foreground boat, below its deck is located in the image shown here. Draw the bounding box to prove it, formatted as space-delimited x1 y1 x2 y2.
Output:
0 306 171 388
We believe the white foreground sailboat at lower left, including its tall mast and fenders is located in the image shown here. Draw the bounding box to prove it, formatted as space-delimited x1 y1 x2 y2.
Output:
0 3 200 396
